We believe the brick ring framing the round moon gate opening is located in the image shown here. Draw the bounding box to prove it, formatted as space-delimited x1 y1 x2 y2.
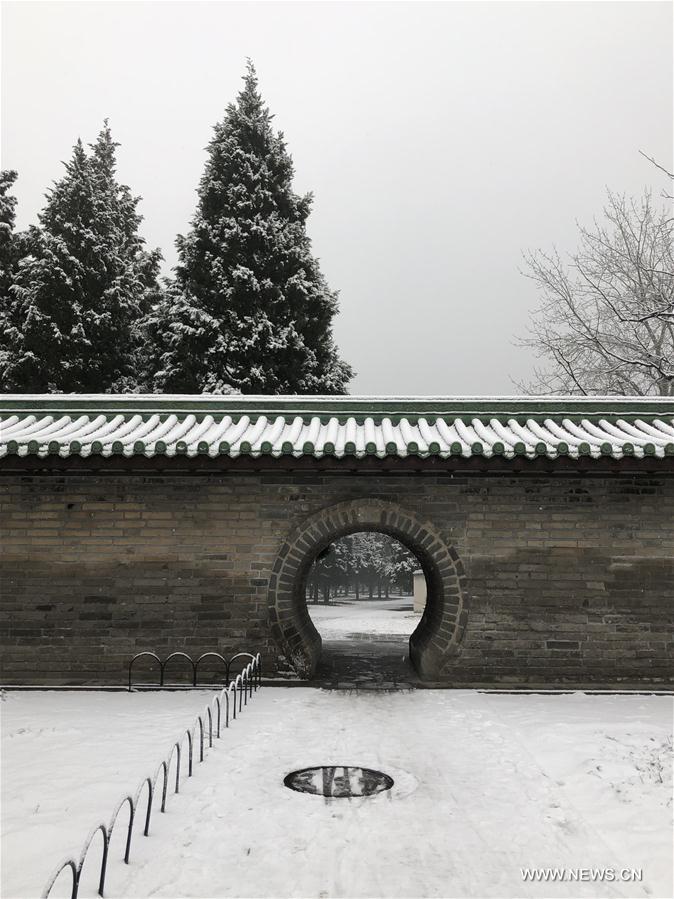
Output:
269 500 468 680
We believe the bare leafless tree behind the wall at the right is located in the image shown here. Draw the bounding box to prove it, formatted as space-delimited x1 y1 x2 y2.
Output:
518 192 674 396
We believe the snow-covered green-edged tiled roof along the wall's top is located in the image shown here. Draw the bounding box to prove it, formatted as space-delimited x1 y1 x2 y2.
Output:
0 394 674 459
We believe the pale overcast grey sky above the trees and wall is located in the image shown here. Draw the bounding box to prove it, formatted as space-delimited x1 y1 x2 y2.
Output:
2 0 673 394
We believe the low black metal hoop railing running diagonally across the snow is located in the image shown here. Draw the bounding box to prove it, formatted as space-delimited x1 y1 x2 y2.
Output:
42 653 262 899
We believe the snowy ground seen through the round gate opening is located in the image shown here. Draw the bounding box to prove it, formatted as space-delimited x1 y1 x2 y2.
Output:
307 596 421 640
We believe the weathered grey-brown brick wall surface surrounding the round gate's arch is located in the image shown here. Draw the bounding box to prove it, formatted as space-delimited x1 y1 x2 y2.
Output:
0 472 674 686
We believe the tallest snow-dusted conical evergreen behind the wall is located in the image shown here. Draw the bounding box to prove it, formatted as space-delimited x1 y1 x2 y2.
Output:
150 63 352 394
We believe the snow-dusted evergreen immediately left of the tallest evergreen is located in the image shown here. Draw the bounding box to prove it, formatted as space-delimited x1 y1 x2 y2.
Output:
0 122 161 392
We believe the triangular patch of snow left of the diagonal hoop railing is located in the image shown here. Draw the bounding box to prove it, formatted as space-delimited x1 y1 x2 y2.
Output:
0 690 215 897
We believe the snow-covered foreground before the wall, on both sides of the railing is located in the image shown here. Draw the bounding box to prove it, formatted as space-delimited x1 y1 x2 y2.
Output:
2 688 673 899
